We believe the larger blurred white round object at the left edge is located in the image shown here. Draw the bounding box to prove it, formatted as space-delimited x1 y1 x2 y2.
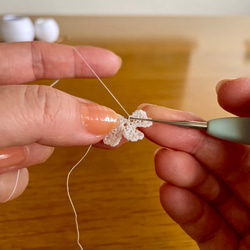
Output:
1 15 35 42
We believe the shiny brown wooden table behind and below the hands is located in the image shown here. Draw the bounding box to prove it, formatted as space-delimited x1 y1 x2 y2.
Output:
0 17 250 250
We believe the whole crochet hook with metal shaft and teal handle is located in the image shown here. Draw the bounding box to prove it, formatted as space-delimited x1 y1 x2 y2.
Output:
129 117 250 145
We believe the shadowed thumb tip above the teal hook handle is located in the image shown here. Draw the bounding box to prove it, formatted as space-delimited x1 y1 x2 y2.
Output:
216 77 250 116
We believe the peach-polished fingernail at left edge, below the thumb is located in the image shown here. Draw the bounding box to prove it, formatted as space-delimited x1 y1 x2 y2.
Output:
0 147 27 169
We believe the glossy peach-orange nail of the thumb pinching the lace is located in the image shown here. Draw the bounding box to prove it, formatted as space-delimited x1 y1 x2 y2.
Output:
80 103 118 135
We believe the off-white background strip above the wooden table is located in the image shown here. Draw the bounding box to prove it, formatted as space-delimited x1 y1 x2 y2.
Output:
0 0 250 16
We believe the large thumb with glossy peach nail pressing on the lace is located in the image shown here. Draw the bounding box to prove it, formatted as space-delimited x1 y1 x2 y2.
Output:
0 85 118 148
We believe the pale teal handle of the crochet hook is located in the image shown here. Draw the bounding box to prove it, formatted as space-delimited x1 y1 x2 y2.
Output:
206 117 250 145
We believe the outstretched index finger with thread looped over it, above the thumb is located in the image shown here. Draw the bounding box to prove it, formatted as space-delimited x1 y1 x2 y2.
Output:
0 42 121 85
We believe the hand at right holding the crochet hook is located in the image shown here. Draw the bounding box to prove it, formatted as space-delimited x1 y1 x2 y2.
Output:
139 78 250 250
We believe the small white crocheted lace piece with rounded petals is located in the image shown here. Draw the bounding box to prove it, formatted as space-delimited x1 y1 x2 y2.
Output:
103 109 153 147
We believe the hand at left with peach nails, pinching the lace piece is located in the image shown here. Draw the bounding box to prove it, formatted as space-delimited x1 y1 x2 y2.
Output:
0 42 121 202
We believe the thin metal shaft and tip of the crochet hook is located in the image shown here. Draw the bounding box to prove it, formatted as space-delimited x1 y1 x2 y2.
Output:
127 117 207 130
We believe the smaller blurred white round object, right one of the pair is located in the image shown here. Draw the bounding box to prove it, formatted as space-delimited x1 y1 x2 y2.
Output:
35 18 60 43
